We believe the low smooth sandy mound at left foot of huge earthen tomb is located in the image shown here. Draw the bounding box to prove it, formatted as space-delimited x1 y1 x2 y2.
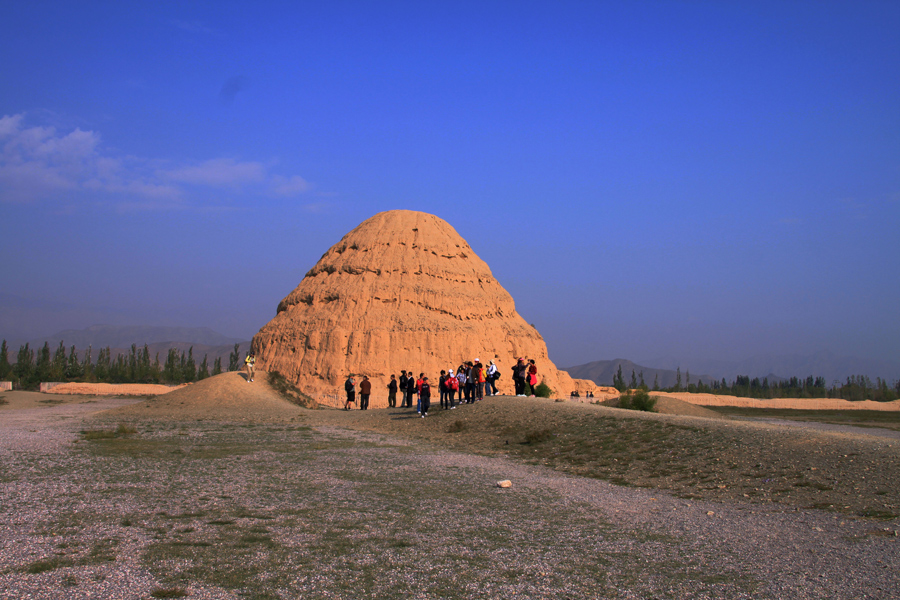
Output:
101 372 304 421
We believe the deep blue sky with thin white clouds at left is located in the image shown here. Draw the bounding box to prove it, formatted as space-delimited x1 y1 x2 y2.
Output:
0 0 900 366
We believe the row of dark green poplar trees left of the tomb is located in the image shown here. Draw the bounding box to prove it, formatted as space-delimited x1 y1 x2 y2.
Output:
0 340 241 390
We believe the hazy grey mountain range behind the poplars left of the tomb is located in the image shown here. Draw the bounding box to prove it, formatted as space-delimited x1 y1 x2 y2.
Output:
22 325 250 368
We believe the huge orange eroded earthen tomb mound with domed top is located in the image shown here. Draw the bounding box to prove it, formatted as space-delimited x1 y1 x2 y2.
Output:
252 210 595 407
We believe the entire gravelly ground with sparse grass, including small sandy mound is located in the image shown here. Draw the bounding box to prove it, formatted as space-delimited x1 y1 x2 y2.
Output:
0 373 900 599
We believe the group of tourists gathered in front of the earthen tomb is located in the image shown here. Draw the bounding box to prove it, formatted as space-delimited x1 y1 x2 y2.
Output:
344 358 537 412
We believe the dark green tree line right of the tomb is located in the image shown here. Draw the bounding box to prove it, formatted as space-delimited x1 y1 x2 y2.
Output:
613 365 900 402
